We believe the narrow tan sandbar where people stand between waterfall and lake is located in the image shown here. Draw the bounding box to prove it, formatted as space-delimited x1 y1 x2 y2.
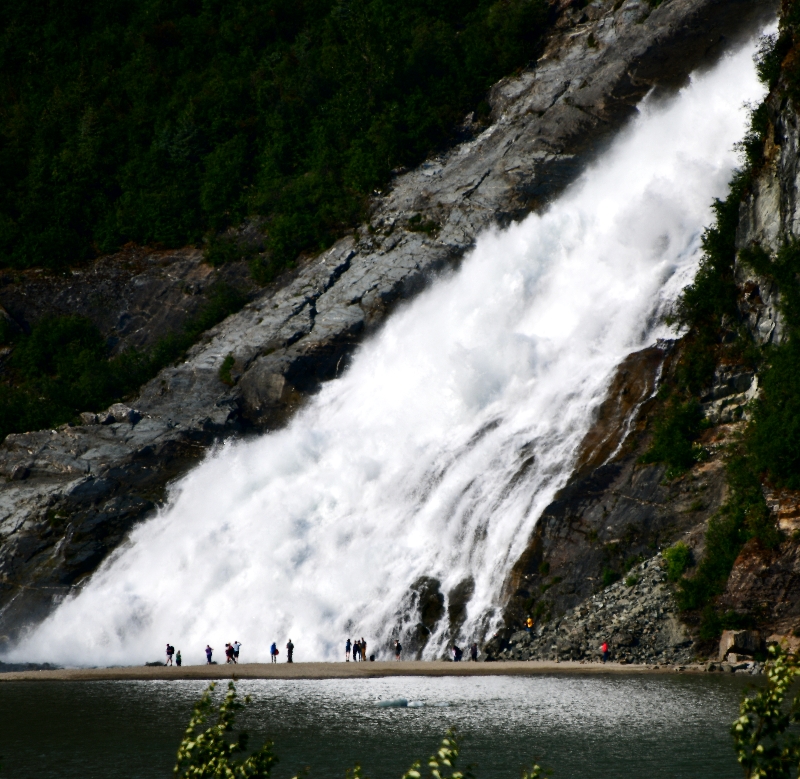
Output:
0 661 703 682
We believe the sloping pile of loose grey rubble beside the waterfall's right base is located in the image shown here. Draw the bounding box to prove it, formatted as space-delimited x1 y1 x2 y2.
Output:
490 554 695 665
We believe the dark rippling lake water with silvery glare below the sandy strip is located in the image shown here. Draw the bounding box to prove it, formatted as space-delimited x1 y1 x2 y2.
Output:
0 674 751 779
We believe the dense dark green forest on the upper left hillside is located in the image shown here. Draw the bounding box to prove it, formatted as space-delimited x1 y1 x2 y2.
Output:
0 0 548 281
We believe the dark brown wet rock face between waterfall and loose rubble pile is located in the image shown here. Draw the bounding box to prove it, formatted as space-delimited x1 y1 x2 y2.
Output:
505 350 741 633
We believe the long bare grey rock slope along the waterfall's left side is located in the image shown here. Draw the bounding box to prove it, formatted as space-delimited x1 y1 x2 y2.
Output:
0 0 772 640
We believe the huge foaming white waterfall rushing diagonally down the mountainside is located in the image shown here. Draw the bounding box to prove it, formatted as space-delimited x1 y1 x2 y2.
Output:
13 32 763 665
